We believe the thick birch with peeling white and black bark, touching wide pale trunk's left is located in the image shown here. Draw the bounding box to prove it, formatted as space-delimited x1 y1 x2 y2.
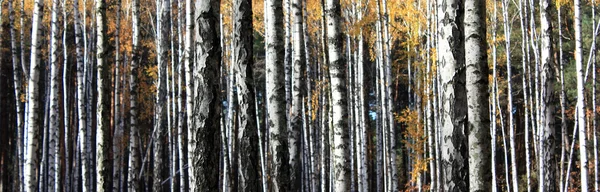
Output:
438 0 469 191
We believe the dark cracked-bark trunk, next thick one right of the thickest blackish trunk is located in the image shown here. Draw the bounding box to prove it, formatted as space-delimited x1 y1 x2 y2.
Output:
232 0 261 191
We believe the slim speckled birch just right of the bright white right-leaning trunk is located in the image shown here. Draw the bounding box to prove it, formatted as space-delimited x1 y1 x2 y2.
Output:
47 0 60 191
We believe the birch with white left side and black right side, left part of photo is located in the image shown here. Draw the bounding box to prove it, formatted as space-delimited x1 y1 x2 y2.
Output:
95 0 112 191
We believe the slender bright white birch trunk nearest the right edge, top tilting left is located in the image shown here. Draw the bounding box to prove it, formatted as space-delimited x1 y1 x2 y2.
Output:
574 0 588 191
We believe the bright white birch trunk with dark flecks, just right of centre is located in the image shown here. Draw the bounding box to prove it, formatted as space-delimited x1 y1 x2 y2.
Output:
324 0 351 191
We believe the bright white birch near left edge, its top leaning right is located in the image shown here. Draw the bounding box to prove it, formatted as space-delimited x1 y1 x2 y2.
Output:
23 0 44 191
